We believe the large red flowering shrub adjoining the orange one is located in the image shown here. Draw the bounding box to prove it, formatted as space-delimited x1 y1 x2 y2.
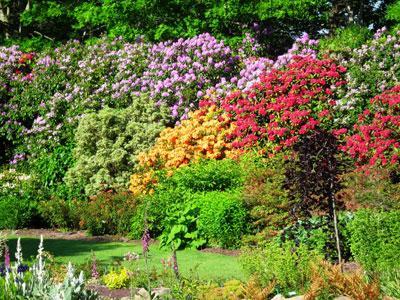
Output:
222 57 346 150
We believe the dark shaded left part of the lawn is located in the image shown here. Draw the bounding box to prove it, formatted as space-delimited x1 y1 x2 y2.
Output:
8 237 132 261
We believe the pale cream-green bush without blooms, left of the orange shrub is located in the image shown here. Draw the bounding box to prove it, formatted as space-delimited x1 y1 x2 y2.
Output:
65 97 168 195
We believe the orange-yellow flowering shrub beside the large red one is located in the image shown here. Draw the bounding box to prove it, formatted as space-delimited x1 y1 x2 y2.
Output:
130 105 239 195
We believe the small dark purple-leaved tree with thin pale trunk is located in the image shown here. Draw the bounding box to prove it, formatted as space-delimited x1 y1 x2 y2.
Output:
284 131 344 263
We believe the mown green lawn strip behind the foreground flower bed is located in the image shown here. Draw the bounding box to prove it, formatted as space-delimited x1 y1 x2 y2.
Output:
9 236 246 280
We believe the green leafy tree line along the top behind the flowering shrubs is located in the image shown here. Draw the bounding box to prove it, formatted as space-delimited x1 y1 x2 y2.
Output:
0 0 400 55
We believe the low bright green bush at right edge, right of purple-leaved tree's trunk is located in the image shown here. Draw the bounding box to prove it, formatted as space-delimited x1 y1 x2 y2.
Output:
350 210 400 271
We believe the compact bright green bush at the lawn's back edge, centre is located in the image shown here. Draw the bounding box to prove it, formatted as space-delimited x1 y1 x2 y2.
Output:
193 191 248 248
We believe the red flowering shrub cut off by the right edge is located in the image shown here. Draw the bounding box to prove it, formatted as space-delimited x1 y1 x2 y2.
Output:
343 86 400 166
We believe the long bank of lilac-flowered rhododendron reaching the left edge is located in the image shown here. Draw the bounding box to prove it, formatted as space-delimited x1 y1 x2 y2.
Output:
0 34 322 162
